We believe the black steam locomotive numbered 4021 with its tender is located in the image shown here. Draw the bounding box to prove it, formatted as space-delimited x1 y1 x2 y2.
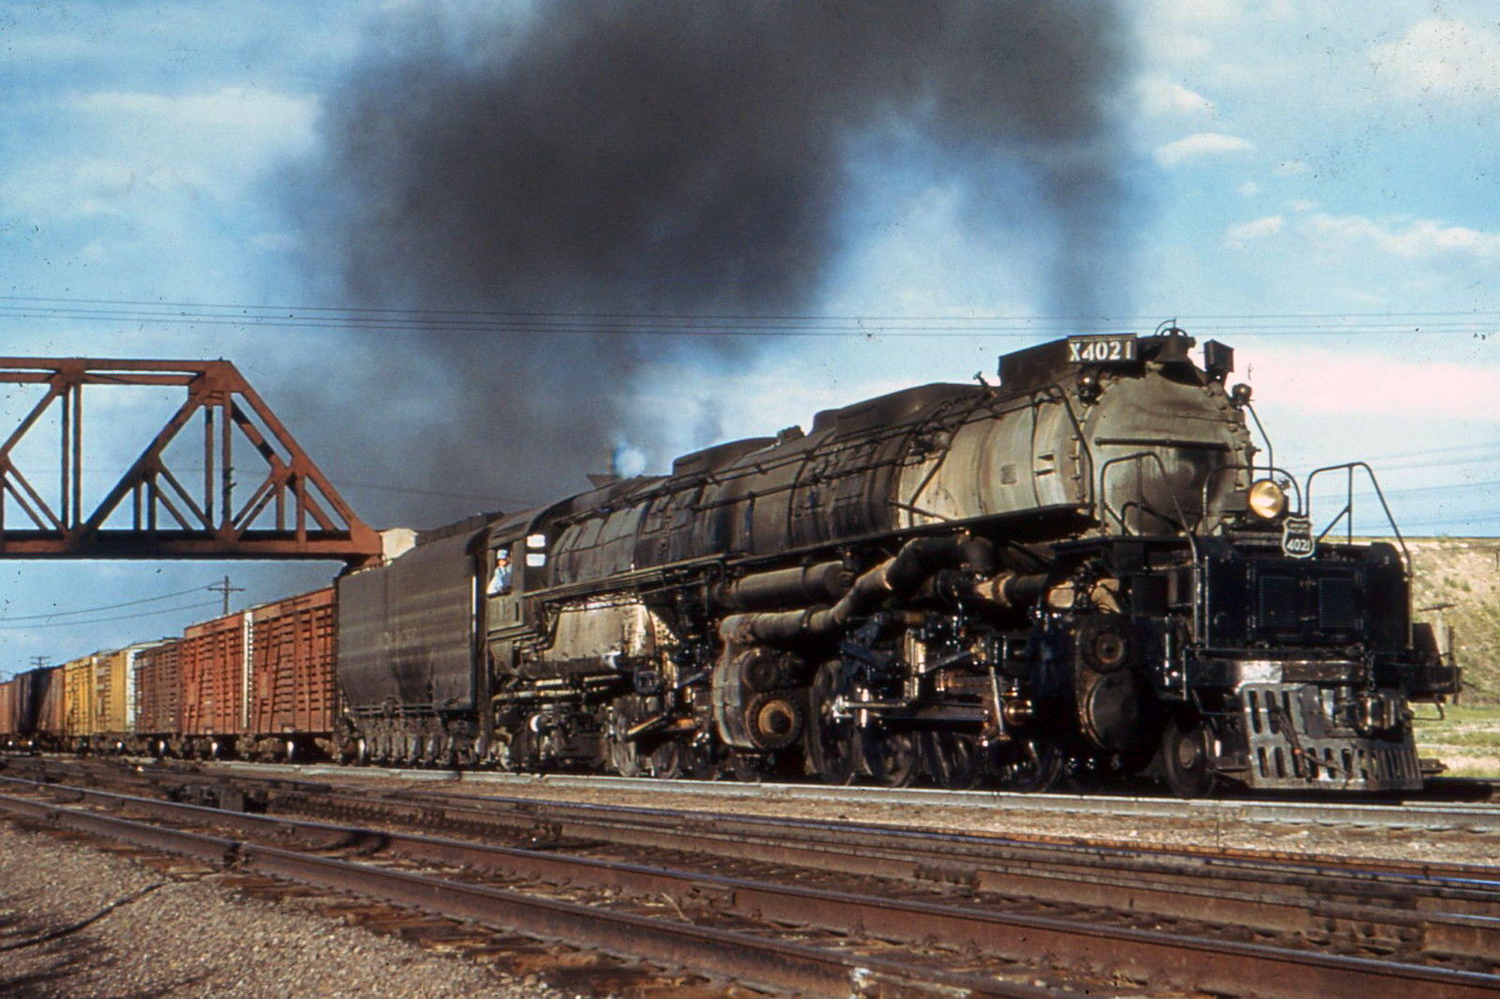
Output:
338 330 1460 795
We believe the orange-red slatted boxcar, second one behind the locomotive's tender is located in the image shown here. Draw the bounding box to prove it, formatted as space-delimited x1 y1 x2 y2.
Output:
180 612 249 756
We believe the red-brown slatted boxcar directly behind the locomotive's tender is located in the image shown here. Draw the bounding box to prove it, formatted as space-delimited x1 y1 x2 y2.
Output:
242 587 338 756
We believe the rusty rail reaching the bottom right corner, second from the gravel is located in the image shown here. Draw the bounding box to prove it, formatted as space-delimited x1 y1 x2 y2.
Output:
0 782 1500 999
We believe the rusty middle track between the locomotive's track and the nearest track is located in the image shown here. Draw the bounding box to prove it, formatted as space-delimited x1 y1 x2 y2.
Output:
11 759 1500 960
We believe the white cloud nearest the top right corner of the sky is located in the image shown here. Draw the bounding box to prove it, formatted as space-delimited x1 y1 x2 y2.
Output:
1370 18 1500 102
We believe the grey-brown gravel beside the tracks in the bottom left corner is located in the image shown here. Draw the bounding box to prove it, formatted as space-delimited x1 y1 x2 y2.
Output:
0 822 572 999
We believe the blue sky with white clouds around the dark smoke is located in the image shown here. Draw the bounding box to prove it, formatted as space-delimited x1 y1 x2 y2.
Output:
0 0 1500 674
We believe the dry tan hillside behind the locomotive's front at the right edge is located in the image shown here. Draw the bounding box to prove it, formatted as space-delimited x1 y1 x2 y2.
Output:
1407 537 1500 705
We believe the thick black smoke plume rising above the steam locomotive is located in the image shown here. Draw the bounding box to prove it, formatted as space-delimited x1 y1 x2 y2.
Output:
298 0 1130 522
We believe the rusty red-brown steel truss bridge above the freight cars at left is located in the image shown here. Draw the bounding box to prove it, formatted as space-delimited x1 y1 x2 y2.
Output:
0 357 381 566
